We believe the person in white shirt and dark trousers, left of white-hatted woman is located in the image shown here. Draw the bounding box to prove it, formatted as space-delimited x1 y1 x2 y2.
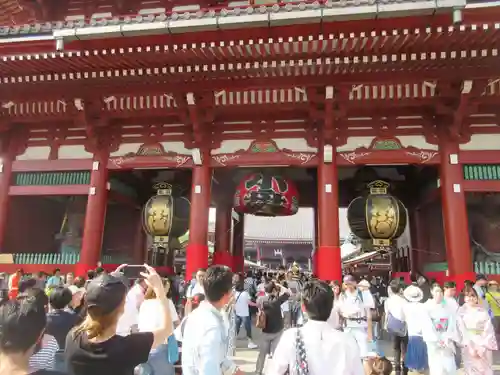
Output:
384 280 408 374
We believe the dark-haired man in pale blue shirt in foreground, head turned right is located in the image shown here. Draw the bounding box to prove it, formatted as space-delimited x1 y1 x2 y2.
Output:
182 266 243 375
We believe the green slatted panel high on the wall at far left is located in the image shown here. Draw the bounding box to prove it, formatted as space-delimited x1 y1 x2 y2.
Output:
12 171 90 186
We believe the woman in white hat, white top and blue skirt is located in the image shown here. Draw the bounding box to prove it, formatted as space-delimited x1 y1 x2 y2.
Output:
403 285 429 374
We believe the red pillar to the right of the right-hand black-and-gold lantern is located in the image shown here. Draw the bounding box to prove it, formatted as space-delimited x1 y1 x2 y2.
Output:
439 137 473 281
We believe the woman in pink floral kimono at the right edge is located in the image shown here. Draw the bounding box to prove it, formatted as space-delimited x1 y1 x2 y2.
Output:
457 287 498 375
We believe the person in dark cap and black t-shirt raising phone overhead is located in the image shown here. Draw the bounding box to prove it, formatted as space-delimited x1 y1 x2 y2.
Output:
66 265 173 375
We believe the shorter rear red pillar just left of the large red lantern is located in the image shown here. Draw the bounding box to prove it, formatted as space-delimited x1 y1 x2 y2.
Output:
212 203 233 268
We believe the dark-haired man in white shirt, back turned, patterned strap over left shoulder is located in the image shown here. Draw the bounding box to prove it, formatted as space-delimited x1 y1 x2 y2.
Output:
266 280 364 375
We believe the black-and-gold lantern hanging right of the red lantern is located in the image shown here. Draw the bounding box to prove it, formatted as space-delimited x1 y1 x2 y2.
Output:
347 180 408 250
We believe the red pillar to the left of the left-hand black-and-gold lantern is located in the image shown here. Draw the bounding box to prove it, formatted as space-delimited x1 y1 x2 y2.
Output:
76 149 109 276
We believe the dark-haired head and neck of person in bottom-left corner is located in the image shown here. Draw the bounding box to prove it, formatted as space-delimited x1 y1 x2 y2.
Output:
0 296 65 375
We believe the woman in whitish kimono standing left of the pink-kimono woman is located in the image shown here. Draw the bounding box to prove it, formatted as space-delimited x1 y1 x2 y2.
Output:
422 284 458 375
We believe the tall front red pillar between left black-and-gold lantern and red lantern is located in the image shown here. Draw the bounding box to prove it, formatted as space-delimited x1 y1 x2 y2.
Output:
186 163 212 279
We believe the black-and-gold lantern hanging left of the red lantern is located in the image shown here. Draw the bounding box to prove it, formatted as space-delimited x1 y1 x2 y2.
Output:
142 182 191 263
